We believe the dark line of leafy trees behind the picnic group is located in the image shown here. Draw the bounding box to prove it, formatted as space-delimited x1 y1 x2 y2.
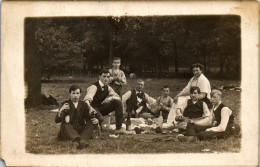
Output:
25 15 241 107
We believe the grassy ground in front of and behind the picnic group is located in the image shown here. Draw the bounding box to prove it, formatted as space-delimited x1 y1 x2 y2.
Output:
26 78 241 154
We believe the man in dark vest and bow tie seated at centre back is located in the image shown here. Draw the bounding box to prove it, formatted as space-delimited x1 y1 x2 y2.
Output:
122 79 156 118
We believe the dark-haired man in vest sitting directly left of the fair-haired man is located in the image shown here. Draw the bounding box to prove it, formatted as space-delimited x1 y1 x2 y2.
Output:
175 86 210 129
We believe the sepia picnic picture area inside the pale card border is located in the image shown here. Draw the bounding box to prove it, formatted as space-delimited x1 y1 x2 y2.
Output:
24 15 243 154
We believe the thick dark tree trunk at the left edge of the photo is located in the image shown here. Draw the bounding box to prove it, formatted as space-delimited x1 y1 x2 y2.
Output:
25 20 42 107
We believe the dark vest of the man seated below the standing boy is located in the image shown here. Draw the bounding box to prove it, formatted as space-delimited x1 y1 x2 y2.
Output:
91 82 108 107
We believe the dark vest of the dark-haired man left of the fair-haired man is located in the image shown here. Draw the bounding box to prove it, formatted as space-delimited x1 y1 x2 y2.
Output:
183 99 203 118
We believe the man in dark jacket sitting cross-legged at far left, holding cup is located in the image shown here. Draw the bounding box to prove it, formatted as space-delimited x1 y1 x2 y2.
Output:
55 85 98 150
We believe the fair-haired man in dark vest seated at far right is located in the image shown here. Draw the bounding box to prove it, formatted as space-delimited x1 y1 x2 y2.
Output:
179 90 240 140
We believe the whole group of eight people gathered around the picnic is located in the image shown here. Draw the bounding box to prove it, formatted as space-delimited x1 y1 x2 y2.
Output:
55 57 240 149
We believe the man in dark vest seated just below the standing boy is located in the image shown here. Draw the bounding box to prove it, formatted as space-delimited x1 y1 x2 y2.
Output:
83 70 132 134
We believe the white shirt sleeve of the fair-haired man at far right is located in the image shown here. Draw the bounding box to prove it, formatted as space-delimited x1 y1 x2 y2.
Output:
208 107 232 132
